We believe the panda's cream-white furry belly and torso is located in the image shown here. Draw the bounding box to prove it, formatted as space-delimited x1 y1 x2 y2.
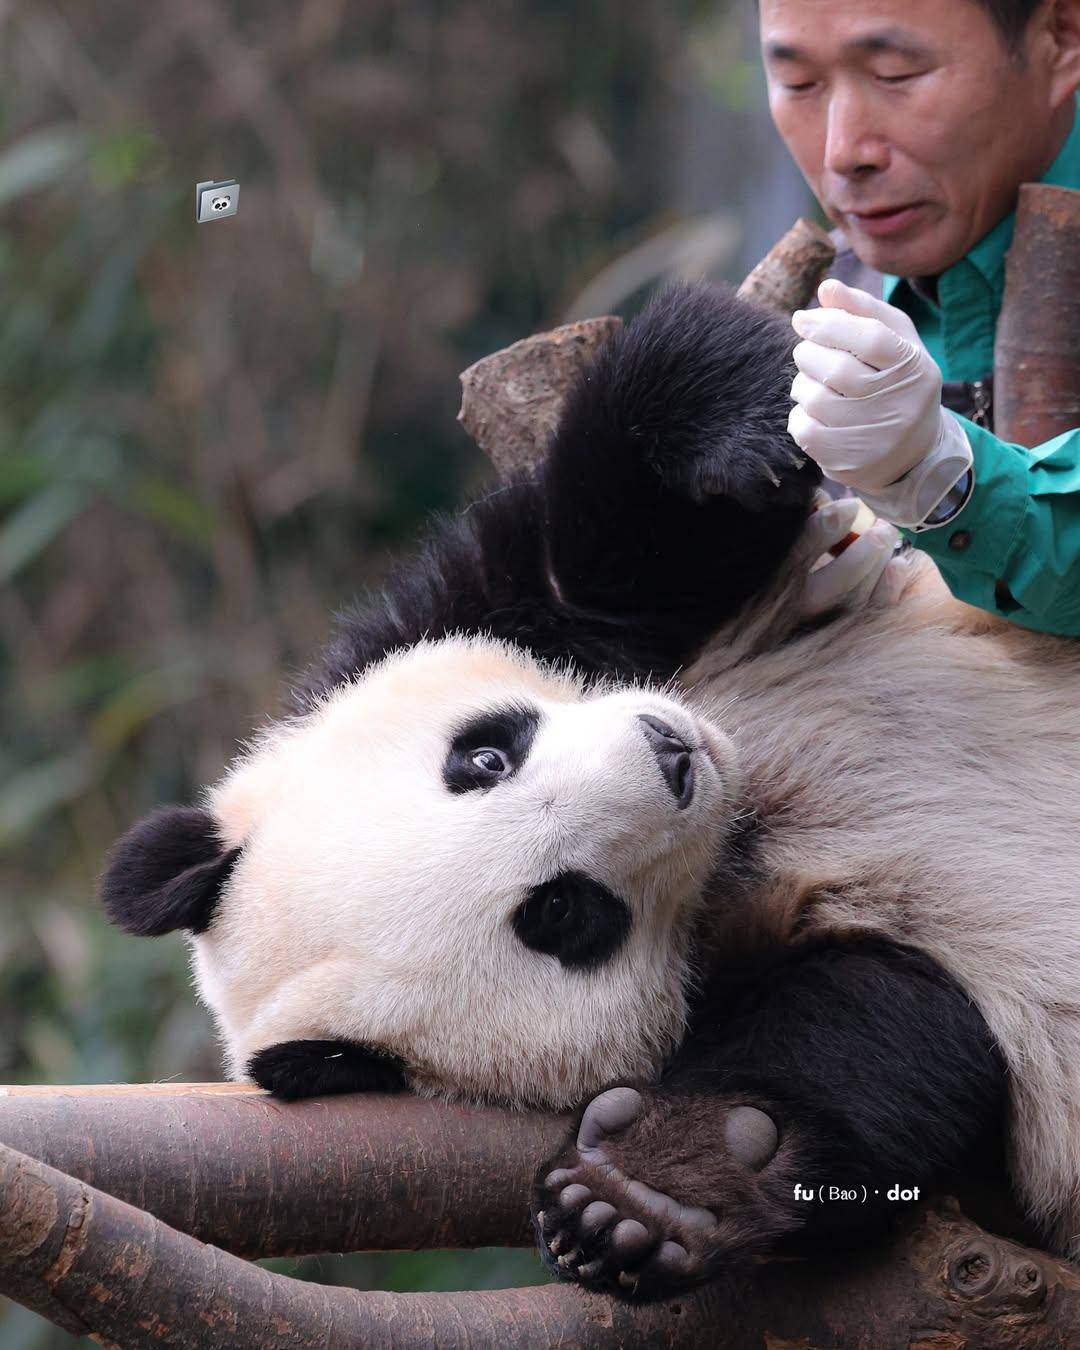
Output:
690 580 1080 1256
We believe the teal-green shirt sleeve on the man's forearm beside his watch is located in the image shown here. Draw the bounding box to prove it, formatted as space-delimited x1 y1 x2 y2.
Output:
905 414 1080 637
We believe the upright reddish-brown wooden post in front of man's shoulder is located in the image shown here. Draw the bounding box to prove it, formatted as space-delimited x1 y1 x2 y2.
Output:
994 184 1080 447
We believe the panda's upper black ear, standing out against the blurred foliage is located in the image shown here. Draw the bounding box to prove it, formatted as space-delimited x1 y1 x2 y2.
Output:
101 806 240 937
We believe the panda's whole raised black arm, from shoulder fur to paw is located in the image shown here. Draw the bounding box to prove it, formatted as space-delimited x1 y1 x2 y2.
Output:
297 288 821 707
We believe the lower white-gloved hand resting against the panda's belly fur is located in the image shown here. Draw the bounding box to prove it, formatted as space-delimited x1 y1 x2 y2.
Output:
802 497 900 617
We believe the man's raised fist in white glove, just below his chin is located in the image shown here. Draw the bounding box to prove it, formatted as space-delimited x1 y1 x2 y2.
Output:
787 281 973 527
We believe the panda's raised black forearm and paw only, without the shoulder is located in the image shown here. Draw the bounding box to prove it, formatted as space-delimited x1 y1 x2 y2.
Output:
544 286 821 659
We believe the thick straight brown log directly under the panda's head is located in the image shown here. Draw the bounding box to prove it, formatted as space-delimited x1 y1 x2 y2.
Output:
0 1084 567 1257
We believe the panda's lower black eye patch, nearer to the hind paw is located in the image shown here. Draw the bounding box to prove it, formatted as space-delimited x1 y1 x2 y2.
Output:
513 872 630 971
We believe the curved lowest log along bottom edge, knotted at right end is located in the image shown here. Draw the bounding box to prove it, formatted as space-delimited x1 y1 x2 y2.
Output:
0 1146 1080 1350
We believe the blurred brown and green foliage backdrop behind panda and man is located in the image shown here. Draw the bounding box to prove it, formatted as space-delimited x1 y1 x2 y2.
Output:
0 0 813 1333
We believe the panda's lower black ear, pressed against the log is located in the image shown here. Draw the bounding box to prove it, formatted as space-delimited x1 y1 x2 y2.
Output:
247 1041 409 1102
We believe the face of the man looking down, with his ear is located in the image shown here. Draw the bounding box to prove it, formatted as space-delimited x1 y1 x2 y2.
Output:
760 0 1061 277
